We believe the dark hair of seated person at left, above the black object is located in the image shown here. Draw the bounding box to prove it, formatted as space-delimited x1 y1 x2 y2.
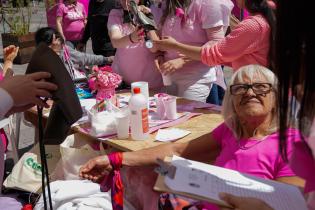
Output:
35 27 64 45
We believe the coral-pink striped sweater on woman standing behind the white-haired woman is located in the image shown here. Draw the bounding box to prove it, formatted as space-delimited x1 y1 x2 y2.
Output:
201 15 270 70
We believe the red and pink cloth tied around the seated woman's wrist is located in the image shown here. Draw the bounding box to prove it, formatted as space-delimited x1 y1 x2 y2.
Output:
100 152 124 210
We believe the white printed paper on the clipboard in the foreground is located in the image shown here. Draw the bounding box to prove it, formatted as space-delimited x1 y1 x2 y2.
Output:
165 156 307 210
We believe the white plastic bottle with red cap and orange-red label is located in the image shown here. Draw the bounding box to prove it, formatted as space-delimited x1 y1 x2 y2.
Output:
129 87 149 140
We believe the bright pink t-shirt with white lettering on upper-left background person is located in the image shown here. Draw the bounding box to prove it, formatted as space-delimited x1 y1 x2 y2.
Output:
56 2 86 41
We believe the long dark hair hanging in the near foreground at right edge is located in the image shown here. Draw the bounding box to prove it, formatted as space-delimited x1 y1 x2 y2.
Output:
275 0 315 160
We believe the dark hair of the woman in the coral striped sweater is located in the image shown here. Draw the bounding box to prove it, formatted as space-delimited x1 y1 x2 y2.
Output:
245 0 276 70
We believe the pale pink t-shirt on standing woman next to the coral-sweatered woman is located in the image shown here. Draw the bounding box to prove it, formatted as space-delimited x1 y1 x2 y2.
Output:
152 0 233 82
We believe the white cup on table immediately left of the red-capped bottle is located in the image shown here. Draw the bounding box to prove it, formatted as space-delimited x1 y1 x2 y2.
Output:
116 109 130 139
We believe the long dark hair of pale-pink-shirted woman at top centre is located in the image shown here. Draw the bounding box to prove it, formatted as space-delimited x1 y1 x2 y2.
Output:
160 0 192 26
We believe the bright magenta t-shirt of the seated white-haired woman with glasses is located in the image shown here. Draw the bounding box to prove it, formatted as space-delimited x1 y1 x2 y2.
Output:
212 123 300 180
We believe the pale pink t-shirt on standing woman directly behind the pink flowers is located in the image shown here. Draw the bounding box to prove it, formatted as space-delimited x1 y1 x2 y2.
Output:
107 9 163 89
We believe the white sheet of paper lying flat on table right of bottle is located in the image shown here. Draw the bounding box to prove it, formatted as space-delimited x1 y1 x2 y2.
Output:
155 128 191 142
